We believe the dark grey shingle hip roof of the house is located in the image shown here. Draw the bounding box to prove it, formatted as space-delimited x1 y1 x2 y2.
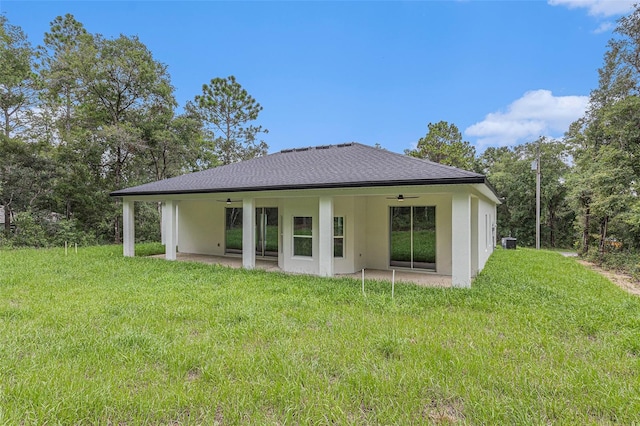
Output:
111 143 486 196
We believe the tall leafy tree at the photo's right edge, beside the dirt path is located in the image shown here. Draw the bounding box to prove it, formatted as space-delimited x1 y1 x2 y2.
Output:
566 6 640 255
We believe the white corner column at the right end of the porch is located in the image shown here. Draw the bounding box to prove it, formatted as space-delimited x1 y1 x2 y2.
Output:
451 194 471 287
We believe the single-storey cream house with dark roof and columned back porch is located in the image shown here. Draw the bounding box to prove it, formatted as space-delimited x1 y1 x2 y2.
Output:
111 143 500 287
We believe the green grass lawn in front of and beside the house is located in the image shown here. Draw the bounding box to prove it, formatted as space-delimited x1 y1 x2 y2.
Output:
0 246 640 424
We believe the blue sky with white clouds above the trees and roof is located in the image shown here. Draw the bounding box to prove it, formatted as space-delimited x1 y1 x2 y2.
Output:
0 0 633 152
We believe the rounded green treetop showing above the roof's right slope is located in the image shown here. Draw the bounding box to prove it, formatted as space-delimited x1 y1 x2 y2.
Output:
405 121 477 170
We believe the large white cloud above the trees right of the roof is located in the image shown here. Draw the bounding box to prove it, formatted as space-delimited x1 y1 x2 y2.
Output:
464 90 589 146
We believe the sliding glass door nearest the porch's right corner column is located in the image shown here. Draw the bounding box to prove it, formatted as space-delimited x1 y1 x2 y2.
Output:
389 206 436 270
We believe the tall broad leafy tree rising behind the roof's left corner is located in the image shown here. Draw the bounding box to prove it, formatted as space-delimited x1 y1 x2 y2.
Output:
72 35 175 242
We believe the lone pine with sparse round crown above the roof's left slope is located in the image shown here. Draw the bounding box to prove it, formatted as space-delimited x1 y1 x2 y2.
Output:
193 76 268 165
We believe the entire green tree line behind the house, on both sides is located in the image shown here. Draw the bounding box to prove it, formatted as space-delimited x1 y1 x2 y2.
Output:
0 7 640 262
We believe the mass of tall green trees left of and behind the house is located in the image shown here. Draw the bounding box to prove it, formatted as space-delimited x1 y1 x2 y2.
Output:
0 14 268 246
